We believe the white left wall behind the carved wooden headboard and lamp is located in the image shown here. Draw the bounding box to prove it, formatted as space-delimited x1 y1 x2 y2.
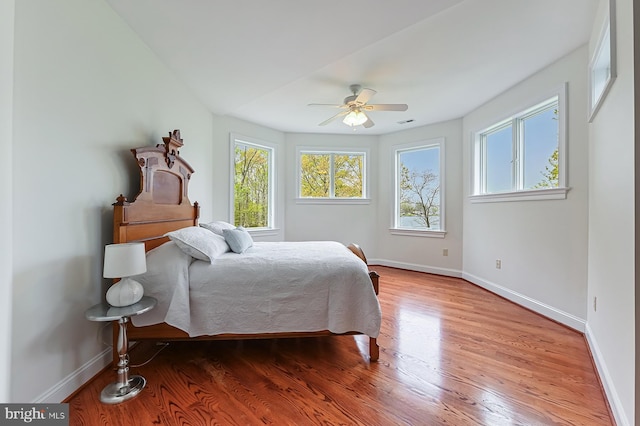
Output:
11 0 213 402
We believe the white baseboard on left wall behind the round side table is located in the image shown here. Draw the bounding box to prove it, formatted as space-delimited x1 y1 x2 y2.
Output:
33 348 115 404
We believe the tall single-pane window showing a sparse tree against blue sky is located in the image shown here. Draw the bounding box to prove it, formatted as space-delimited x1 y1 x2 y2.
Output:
392 139 444 237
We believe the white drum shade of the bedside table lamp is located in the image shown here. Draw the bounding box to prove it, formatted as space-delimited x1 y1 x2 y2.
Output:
102 243 147 278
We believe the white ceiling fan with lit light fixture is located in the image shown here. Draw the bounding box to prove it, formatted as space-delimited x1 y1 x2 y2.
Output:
309 84 409 128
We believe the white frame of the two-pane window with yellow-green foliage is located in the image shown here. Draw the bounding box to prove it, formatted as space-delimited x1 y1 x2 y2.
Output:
295 146 371 204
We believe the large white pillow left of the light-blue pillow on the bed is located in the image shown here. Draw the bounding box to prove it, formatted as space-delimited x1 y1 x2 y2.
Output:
165 226 229 262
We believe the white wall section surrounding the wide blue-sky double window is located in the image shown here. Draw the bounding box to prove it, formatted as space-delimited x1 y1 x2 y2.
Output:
462 47 588 330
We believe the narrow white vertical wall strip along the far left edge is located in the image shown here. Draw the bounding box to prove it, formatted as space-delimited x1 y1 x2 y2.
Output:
0 0 15 402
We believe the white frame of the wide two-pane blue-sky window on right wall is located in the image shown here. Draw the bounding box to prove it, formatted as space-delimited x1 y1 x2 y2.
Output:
468 83 570 203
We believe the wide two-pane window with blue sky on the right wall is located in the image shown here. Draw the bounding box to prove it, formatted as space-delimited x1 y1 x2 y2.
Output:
472 86 566 201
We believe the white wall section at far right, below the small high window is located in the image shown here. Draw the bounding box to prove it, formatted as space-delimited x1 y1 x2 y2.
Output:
587 0 637 425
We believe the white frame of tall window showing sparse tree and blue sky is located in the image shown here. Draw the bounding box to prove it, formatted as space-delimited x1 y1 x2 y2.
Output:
389 137 447 238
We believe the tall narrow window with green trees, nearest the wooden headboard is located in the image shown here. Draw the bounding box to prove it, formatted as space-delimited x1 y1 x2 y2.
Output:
231 135 275 228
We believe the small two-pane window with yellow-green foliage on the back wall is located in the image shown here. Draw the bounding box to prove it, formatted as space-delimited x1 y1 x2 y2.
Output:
297 148 367 202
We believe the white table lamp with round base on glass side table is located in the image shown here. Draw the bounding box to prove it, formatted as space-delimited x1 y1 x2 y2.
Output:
102 243 147 307
